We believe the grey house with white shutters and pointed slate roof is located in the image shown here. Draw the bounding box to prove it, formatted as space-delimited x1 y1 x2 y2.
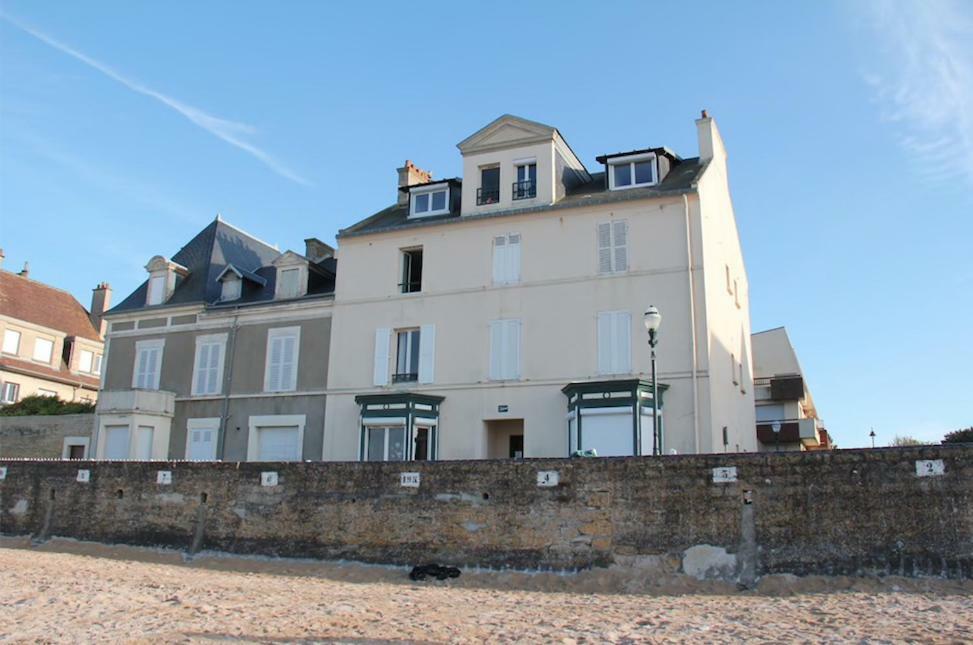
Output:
94 217 336 461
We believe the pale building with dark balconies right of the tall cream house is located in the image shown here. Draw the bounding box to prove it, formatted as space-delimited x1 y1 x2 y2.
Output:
751 327 833 451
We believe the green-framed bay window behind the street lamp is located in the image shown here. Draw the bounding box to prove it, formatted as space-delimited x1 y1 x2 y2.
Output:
561 379 669 457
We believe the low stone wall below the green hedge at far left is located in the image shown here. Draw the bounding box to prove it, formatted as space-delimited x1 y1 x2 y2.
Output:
0 414 95 459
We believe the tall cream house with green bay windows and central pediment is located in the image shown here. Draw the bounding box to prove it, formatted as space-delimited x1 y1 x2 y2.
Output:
322 112 757 461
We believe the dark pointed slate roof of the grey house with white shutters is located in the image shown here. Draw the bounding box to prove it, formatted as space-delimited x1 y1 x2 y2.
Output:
109 218 336 314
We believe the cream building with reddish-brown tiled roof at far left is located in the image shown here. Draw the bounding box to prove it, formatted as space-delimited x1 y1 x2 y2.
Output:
0 251 111 404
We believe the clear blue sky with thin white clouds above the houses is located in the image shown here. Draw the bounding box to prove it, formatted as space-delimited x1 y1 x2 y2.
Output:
0 0 973 447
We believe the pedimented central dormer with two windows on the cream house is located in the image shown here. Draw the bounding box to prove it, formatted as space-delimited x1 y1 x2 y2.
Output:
456 114 591 215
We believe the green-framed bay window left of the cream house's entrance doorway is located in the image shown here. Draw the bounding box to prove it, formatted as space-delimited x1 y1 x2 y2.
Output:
355 392 445 461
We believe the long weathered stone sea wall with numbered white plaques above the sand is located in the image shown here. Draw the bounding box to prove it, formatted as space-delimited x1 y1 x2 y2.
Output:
0 445 973 582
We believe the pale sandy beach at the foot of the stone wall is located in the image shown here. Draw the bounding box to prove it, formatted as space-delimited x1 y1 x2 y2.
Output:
0 539 973 643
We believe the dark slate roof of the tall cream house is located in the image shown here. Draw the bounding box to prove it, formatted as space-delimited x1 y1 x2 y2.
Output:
338 157 707 238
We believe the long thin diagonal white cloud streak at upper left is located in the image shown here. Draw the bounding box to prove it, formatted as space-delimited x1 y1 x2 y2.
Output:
0 12 309 186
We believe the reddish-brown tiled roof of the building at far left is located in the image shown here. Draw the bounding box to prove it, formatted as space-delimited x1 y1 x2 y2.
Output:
0 271 101 340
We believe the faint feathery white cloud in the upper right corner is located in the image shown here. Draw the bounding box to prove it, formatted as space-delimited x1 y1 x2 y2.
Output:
863 0 973 185
